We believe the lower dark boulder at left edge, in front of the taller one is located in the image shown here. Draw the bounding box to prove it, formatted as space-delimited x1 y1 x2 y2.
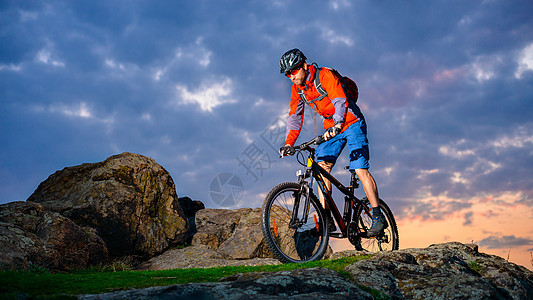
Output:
0 202 108 271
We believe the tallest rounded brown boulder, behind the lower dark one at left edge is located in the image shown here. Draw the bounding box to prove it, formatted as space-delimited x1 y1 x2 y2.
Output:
28 153 189 258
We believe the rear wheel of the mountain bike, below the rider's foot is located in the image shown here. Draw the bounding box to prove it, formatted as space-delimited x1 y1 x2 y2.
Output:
349 197 400 252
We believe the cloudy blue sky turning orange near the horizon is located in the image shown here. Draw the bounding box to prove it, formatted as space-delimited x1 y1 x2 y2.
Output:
0 0 533 269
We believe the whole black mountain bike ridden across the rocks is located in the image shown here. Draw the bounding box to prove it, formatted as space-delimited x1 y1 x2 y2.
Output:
261 136 399 263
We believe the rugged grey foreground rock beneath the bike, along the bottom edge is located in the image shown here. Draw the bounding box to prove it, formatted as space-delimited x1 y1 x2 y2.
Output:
80 242 533 299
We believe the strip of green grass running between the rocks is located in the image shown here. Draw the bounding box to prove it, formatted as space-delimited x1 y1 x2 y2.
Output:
0 256 369 299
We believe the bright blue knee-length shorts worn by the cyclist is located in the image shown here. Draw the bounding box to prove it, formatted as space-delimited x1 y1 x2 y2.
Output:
316 119 370 170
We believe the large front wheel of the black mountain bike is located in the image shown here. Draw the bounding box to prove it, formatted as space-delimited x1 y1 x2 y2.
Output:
261 182 329 263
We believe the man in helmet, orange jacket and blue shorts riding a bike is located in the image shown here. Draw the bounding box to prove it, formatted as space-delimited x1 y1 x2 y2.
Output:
279 49 388 236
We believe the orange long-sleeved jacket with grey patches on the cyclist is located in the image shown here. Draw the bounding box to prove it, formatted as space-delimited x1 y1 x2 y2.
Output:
285 65 359 146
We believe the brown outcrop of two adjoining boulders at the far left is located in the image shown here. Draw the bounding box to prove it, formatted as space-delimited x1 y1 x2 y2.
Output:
0 153 208 271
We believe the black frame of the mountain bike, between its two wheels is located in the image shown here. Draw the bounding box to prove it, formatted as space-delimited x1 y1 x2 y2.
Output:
293 144 371 238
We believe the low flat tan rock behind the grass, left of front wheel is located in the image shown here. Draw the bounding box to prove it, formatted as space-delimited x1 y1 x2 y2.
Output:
136 245 280 270
